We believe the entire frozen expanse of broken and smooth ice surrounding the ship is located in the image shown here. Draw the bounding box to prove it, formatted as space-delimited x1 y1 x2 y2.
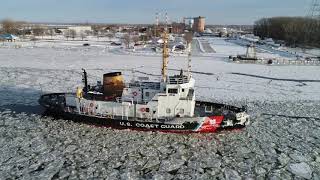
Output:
0 38 320 179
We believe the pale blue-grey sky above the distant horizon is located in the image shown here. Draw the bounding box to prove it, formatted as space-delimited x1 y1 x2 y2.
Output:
0 0 311 24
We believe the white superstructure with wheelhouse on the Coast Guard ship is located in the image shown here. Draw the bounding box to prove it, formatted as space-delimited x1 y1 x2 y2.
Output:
77 71 195 120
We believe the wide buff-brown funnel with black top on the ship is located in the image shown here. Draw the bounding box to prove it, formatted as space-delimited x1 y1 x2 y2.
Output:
103 72 124 99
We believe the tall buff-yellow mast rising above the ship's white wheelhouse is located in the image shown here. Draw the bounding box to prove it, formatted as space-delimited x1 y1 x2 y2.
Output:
161 14 169 82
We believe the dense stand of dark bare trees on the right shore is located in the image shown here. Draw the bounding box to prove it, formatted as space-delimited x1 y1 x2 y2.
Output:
253 17 320 47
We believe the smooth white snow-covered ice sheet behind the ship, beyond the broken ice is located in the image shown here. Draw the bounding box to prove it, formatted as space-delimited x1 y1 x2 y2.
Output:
0 42 320 101
